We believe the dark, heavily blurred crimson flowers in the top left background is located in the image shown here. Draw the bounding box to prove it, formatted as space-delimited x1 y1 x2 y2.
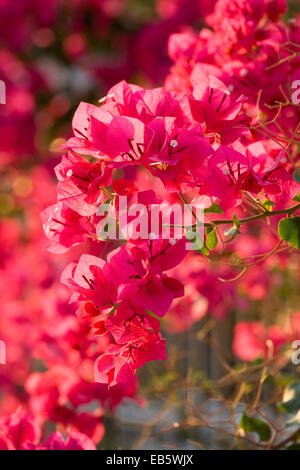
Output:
0 0 216 173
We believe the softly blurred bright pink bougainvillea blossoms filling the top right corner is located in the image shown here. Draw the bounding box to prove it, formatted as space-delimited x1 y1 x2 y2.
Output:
166 0 300 136
